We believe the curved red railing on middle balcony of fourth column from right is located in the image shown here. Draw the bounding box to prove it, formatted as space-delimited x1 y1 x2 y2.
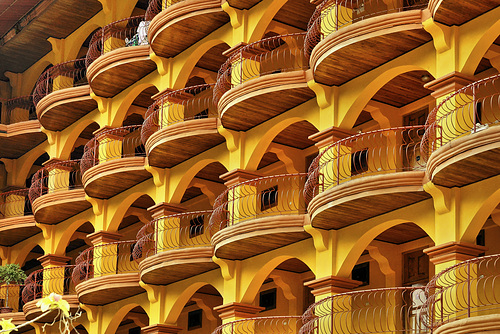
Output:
141 84 218 143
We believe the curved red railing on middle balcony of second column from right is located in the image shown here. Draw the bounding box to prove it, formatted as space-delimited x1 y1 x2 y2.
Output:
304 125 425 203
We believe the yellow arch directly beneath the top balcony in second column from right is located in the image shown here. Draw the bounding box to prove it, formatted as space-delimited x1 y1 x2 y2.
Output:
339 65 426 129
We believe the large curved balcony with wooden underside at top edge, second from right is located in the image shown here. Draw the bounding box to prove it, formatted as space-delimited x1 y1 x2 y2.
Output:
305 0 432 86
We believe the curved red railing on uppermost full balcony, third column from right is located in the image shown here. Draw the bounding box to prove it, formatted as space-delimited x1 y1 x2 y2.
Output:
214 33 309 103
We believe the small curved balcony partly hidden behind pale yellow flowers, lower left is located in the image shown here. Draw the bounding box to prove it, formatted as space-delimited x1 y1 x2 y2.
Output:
22 265 80 323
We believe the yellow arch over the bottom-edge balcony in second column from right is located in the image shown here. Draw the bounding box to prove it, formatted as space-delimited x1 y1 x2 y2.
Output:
336 218 434 277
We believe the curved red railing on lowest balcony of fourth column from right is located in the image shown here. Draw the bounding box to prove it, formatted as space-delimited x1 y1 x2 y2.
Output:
133 210 212 261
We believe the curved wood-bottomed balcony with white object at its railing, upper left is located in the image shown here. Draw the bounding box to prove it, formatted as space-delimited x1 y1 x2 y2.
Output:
86 15 156 98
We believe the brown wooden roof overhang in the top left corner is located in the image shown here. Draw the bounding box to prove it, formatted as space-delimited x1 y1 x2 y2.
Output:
0 0 102 81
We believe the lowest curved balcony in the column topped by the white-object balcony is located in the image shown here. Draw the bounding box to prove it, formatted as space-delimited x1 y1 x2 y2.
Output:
73 240 144 305
